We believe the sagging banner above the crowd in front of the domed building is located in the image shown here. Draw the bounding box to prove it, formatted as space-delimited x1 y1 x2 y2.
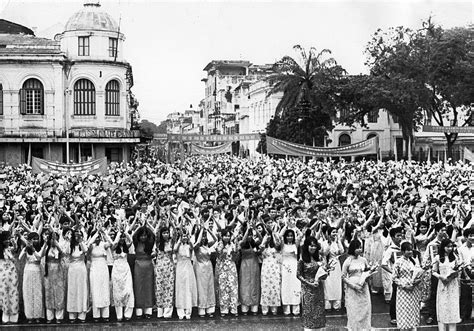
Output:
31 157 107 176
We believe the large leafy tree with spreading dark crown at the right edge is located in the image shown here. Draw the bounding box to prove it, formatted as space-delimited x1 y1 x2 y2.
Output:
362 18 474 156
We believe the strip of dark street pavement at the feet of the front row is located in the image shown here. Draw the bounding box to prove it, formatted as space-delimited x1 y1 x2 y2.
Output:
0 295 474 331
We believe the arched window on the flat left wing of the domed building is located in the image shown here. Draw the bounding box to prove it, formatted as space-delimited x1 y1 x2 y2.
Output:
20 78 44 115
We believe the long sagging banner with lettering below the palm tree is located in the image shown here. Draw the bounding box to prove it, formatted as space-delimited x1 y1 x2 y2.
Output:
267 136 378 157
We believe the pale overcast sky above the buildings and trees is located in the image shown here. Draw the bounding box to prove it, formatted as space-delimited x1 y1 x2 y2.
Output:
0 0 474 124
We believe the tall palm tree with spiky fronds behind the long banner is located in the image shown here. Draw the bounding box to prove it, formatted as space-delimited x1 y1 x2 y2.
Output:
266 45 345 145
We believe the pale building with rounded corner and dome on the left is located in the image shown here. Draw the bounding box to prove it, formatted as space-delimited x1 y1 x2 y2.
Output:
0 3 140 164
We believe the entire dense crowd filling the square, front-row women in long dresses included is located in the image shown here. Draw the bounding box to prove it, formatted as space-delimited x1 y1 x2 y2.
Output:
0 156 474 330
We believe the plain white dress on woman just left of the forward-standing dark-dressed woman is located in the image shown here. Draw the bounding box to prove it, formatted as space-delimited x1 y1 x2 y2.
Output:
281 244 301 305
